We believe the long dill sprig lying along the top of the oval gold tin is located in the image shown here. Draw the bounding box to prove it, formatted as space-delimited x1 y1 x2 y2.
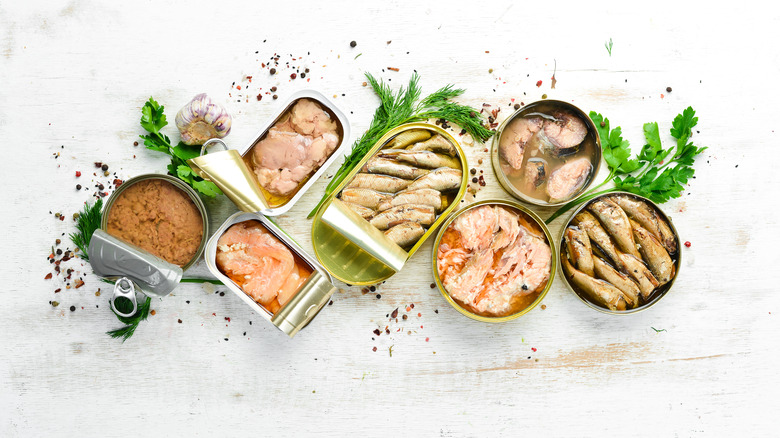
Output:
309 73 493 218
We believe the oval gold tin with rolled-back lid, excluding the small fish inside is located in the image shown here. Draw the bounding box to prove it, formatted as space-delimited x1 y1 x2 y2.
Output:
312 123 468 285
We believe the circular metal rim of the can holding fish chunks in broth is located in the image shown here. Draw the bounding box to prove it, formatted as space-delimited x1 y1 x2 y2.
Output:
490 99 604 207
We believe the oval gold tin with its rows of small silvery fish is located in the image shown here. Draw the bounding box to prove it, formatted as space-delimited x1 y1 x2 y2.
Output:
312 123 468 285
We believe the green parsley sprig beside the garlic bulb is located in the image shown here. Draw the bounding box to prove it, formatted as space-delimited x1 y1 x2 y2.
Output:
140 97 222 198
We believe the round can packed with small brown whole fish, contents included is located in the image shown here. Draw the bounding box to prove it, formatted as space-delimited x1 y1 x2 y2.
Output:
559 192 682 315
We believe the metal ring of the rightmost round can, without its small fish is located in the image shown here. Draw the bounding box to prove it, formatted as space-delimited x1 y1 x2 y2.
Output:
558 192 682 315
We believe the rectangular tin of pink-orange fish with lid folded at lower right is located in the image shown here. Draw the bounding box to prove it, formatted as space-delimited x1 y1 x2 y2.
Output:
205 212 337 337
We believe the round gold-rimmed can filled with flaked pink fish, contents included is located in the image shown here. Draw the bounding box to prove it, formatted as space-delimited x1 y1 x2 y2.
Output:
433 200 557 322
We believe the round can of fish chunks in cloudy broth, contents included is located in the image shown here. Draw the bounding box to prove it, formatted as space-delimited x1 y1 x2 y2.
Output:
490 100 601 207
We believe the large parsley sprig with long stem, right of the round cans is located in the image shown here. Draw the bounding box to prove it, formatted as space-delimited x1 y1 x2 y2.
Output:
546 107 707 224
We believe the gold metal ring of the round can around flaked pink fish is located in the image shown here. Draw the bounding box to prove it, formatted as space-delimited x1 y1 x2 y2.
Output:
432 199 558 323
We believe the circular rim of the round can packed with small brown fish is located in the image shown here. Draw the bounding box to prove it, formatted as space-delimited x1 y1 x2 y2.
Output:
558 190 682 316
